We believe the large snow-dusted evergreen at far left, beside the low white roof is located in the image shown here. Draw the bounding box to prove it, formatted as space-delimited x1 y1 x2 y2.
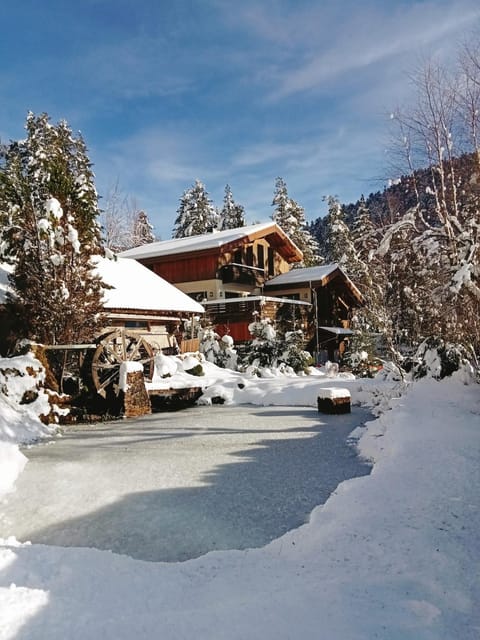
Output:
0 113 103 344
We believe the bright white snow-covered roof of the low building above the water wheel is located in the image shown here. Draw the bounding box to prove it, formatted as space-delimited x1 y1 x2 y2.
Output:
95 256 204 313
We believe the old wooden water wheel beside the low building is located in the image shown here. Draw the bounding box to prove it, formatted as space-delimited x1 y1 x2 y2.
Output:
92 328 153 398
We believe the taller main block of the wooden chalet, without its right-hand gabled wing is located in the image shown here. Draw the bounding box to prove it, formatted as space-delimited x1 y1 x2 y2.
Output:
121 222 310 342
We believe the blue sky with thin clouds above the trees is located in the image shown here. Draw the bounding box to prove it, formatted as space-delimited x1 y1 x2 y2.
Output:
0 0 480 239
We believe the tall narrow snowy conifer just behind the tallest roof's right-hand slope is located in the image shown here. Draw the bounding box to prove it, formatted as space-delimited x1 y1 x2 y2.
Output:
272 178 321 267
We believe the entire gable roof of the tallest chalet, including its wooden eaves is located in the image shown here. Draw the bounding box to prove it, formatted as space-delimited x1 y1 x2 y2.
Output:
119 222 303 262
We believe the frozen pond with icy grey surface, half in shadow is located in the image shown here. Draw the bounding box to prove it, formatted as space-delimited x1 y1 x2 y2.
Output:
0 405 371 562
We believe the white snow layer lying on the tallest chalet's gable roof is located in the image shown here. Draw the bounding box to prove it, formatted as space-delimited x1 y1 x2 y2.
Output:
119 222 300 260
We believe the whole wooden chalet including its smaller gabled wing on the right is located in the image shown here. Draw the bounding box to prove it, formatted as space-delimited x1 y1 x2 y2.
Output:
121 222 362 358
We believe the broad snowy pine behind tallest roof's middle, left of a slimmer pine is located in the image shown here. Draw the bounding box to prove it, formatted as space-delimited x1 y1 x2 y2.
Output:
172 180 218 238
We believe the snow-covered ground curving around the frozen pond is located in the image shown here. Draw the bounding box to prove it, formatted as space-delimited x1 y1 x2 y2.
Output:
0 358 480 640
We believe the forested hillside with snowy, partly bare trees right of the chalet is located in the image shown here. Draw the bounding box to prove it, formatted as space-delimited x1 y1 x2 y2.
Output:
310 45 480 364
